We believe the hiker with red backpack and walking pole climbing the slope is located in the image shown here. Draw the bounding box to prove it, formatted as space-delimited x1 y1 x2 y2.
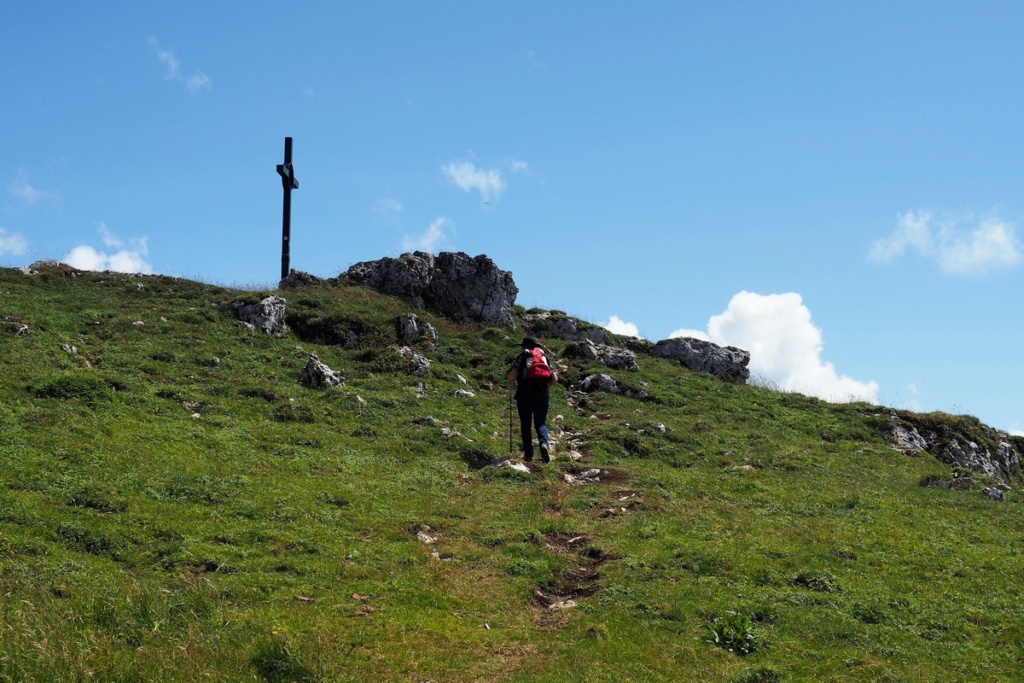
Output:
508 337 558 463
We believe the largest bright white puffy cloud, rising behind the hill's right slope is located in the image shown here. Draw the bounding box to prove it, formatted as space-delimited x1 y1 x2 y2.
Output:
670 292 879 403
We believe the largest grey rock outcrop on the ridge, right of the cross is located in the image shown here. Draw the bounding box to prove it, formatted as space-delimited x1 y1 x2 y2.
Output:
341 252 519 327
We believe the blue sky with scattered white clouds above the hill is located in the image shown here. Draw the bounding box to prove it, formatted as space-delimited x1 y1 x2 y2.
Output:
0 0 1024 431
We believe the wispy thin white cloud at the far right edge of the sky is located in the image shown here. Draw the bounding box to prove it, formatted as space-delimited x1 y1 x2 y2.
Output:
867 211 1024 275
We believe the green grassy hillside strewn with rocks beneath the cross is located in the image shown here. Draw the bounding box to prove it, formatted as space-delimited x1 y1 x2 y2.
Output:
0 267 1024 683
